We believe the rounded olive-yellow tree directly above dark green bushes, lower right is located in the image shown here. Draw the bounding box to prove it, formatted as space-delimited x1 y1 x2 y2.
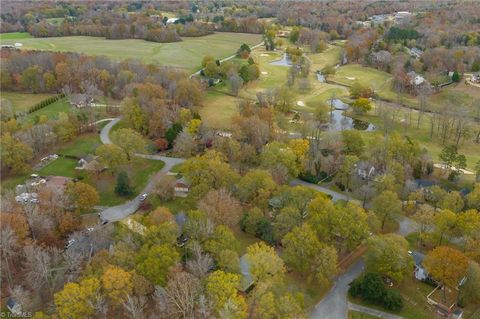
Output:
365 234 413 282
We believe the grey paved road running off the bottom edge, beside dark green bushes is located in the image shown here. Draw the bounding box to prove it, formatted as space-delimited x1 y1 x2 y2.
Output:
310 260 364 319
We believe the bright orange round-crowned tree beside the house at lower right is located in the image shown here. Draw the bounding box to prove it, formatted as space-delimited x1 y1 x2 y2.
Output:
423 246 468 302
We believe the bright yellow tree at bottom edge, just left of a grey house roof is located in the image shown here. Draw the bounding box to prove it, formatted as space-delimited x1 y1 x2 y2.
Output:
205 270 247 319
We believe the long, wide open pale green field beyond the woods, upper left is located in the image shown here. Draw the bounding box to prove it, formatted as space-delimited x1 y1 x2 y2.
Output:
1 32 262 71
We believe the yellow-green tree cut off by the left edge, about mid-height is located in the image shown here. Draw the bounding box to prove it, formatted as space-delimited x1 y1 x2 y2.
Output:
0 133 33 174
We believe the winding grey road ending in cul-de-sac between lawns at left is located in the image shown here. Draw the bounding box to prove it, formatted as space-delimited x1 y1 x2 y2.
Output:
100 118 185 222
